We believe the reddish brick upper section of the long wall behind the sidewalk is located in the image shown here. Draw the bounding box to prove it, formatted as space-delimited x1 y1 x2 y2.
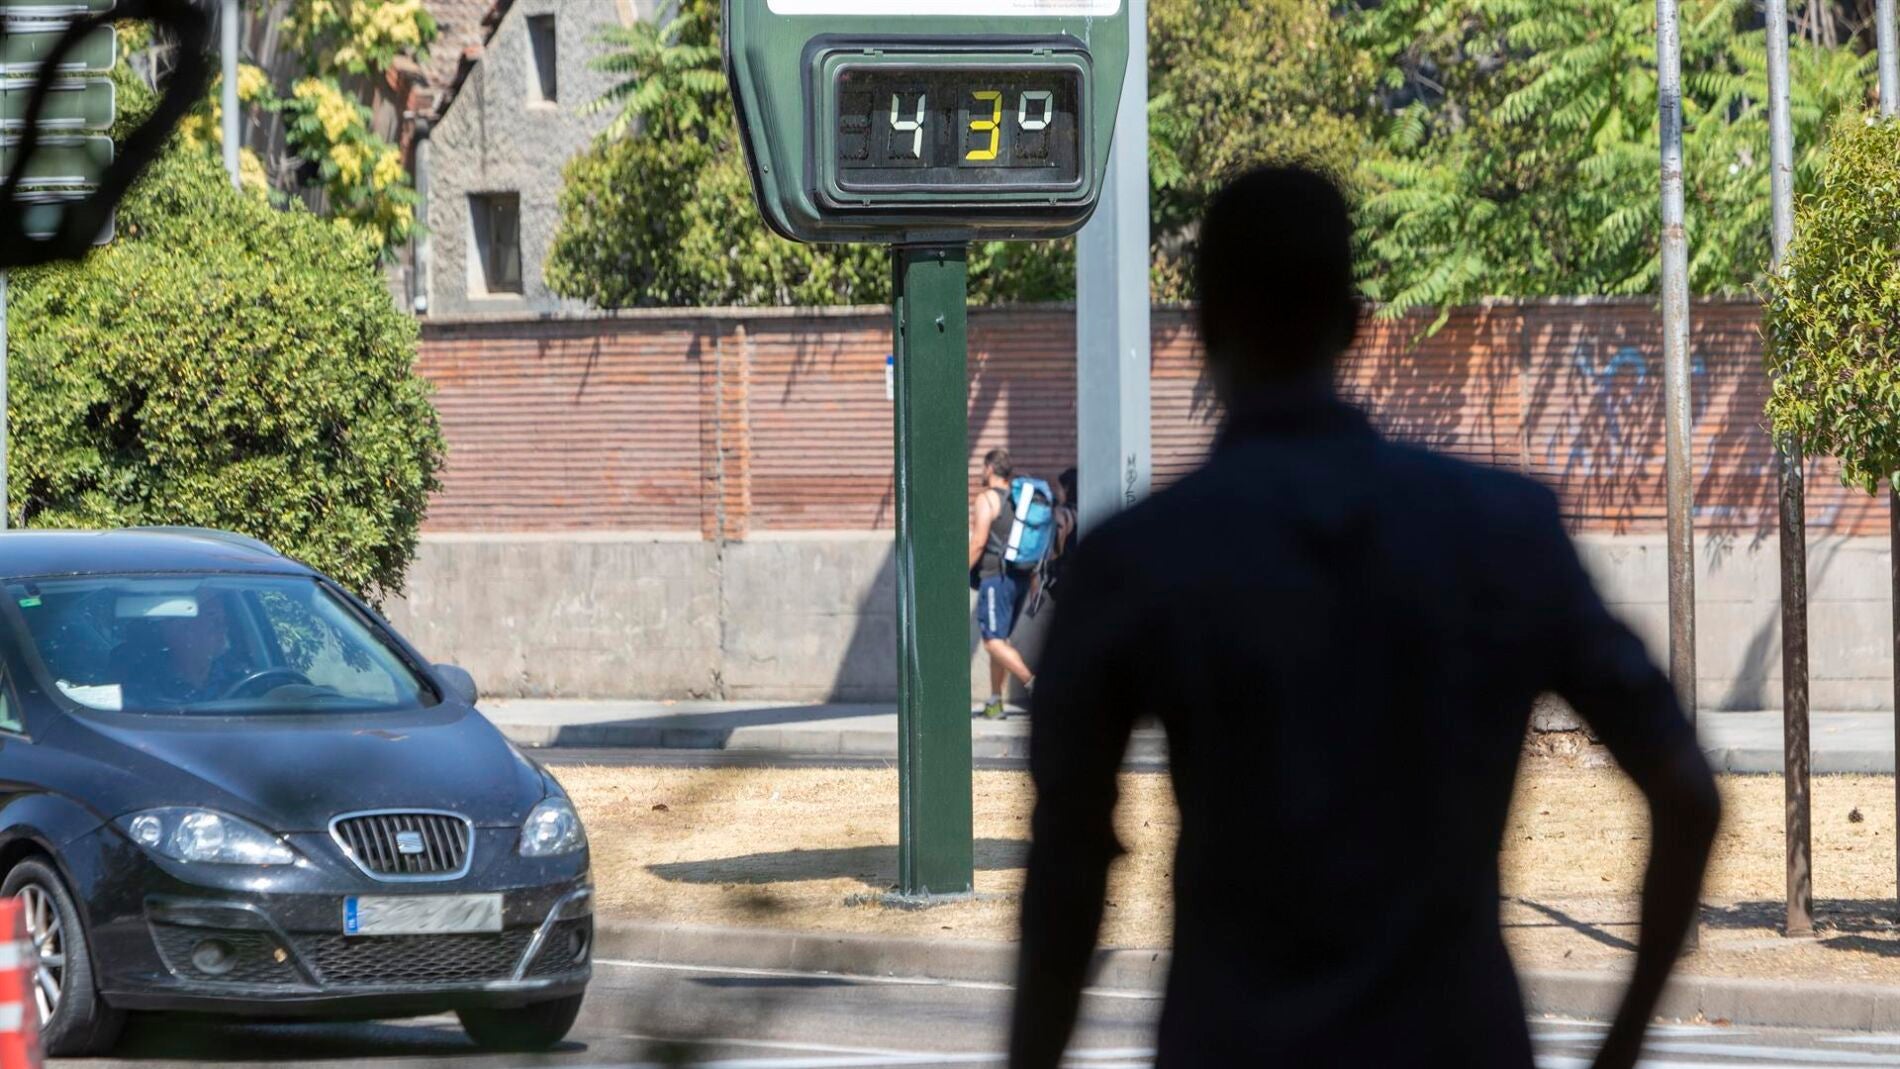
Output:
420 300 1887 539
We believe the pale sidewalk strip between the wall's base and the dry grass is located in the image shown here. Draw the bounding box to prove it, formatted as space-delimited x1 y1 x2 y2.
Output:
485 699 1894 775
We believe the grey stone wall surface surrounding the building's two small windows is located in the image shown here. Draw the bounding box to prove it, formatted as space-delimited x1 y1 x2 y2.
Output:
426 0 638 315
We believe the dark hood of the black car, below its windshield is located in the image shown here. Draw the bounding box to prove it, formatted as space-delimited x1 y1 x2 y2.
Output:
48 703 547 832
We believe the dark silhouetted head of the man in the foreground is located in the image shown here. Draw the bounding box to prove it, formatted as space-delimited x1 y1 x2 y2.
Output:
1195 167 1359 397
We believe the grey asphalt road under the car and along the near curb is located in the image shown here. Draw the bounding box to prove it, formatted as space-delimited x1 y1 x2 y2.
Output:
59 961 1900 1069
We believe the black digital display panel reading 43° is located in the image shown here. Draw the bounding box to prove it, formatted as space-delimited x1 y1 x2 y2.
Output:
834 66 1083 194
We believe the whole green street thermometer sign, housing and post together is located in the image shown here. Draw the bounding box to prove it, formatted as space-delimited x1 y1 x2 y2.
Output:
724 0 1129 900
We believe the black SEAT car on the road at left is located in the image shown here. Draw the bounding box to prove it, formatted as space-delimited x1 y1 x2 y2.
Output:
0 530 593 1054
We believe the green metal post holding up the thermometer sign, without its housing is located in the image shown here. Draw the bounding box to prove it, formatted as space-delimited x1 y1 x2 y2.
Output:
891 247 975 898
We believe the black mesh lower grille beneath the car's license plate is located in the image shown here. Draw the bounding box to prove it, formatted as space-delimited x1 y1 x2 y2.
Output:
298 928 534 987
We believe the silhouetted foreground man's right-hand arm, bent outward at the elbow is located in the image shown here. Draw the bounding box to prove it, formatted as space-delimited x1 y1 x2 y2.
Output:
1537 503 1721 1069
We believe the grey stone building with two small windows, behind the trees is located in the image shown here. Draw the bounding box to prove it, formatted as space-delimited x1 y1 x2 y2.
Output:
414 0 661 315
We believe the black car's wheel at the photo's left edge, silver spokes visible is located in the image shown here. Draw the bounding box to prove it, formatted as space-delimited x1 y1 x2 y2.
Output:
0 858 125 1056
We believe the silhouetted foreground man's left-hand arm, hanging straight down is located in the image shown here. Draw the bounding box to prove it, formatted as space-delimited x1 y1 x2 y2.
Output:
1009 541 1140 1069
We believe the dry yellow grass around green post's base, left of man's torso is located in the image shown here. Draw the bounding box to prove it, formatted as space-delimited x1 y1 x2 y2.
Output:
559 767 1176 946
